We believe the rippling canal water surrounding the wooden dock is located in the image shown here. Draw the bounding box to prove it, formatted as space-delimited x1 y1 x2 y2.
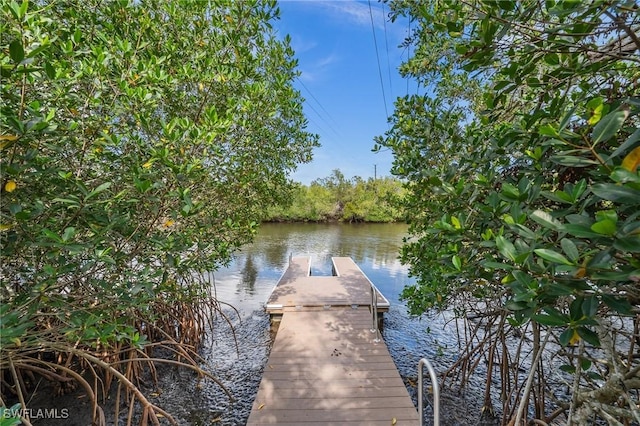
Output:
116 224 476 426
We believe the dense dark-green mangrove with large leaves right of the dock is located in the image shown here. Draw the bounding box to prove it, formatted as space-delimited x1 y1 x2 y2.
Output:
378 0 640 424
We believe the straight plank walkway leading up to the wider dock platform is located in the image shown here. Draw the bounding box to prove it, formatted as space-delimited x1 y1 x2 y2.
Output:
247 309 418 426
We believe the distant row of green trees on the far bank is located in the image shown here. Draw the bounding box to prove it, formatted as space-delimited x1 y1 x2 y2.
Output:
265 170 404 222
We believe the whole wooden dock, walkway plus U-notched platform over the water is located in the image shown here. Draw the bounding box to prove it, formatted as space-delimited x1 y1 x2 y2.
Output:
247 257 419 426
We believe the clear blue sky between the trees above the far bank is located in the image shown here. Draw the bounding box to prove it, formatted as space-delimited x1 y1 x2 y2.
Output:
274 0 416 184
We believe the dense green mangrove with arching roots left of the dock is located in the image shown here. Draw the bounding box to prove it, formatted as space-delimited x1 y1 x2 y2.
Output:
0 0 317 422
